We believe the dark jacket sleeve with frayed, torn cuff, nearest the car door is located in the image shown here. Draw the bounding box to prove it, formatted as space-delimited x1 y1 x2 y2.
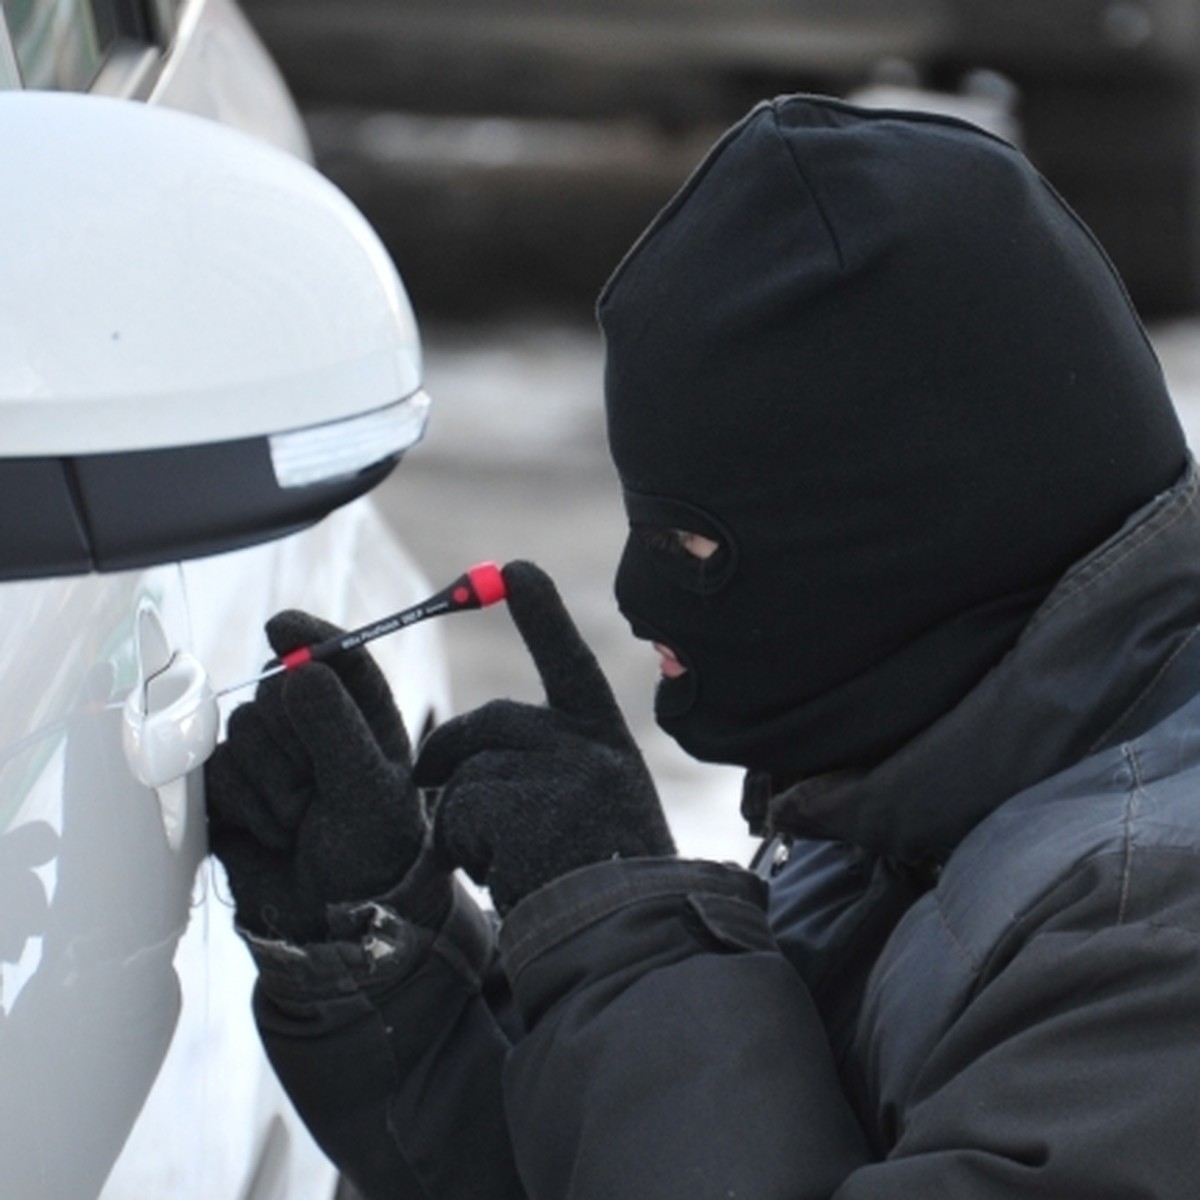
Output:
248 844 524 1200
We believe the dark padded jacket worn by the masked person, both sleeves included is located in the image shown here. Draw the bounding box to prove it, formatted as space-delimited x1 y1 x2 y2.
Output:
248 460 1200 1200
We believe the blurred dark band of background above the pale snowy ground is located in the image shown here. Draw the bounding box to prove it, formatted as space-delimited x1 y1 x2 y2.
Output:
245 0 1200 313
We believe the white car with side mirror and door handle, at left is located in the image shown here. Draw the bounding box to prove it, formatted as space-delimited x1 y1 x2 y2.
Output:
0 9 446 1200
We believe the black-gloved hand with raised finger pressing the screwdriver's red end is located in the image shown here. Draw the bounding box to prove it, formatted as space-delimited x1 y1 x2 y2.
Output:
416 562 674 914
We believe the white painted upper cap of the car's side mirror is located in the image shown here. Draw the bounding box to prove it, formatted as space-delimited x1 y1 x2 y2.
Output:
0 87 421 457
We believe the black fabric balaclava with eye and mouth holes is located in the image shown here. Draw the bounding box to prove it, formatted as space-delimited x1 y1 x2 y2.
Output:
599 96 1186 776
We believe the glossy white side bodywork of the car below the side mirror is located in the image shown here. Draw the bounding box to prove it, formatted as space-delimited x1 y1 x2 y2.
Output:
0 499 448 1200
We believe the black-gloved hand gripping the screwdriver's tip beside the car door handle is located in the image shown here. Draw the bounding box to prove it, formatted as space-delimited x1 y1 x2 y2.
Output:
205 611 426 943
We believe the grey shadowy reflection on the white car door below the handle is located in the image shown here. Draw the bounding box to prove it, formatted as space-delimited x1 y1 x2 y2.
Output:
0 696 203 1196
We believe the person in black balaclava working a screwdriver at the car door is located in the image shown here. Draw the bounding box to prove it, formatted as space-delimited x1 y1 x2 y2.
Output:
208 96 1200 1200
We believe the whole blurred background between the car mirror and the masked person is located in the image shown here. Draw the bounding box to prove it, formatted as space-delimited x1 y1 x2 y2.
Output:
242 0 1200 858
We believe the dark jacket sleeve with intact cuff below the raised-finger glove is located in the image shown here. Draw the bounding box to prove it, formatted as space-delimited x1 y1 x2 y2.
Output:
502 859 866 1200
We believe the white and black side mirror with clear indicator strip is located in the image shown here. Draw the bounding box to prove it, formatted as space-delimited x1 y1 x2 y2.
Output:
0 91 428 580
